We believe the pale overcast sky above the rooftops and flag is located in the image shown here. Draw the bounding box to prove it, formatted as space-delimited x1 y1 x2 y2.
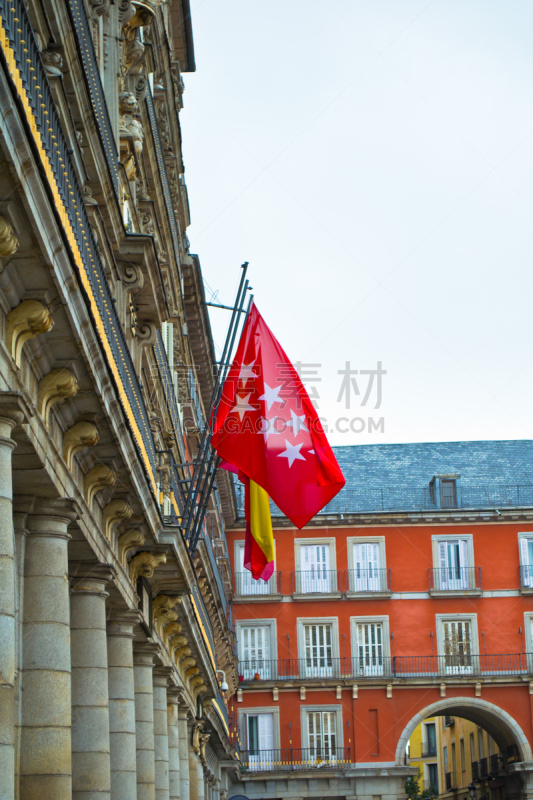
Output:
181 0 533 444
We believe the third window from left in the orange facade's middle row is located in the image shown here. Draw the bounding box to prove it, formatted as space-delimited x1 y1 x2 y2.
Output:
351 617 390 675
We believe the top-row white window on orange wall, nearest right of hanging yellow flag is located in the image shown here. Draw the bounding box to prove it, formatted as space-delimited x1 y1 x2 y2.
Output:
294 539 338 594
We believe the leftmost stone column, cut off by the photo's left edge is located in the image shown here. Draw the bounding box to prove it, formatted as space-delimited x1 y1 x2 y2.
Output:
0 392 24 800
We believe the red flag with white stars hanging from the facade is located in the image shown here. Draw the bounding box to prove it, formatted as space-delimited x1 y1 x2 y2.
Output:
212 305 345 528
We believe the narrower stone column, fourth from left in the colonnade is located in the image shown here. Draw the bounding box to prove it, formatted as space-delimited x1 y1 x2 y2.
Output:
107 610 139 800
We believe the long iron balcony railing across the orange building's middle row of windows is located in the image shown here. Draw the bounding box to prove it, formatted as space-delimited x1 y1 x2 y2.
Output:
239 647 533 681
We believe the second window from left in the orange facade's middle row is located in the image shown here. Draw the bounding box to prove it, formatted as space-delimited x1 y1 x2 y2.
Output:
298 617 339 678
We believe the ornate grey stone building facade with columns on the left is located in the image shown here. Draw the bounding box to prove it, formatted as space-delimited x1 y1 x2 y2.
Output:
0 0 237 800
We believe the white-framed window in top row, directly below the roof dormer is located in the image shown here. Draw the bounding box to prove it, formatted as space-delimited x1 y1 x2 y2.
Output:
431 534 478 592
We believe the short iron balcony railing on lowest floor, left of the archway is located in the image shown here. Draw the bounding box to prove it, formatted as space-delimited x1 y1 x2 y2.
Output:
241 745 353 772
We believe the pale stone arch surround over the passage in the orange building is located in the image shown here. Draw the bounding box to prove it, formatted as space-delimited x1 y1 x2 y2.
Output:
396 697 533 766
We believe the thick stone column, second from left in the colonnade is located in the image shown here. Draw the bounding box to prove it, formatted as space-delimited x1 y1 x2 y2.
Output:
20 500 76 800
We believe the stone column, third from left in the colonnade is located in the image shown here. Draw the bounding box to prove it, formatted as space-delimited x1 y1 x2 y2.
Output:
70 562 112 800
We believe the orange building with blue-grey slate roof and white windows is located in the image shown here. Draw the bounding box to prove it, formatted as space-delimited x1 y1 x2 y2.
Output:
227 441 533 800
